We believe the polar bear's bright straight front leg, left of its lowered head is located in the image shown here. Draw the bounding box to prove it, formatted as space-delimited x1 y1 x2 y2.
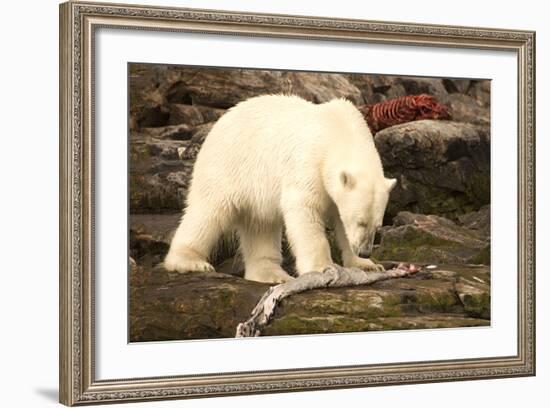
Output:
283 203 333 275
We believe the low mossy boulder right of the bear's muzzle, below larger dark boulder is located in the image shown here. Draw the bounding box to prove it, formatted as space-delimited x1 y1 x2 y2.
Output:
372 211 490 265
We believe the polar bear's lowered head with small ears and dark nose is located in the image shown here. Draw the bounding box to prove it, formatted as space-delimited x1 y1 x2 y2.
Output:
333 171 396 257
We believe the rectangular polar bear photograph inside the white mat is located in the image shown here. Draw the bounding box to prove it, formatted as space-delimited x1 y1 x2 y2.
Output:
128 63 491 342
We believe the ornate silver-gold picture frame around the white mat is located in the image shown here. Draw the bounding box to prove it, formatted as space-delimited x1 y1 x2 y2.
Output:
59 1 536 406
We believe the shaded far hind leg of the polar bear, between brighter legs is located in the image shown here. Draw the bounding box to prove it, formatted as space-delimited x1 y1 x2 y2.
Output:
238 225 293 283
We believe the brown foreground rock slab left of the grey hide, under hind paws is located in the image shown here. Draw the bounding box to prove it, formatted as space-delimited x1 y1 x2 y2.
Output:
130 266 267 341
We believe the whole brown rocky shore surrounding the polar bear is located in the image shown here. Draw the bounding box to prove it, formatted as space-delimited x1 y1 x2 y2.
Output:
129 64 491 341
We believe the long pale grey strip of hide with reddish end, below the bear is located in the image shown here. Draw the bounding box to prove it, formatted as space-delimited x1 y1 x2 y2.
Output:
235 264 419 337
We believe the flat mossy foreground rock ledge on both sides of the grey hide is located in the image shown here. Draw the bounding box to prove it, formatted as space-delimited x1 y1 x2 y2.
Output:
130 263 490 342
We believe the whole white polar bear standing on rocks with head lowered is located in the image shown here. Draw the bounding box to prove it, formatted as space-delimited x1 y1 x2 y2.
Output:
164 95 396 283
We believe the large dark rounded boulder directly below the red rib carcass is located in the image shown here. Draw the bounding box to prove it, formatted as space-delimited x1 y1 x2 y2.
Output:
375 120 490 221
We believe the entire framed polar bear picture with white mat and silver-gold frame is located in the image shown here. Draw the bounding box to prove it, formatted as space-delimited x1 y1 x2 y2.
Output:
59 1 536 406
